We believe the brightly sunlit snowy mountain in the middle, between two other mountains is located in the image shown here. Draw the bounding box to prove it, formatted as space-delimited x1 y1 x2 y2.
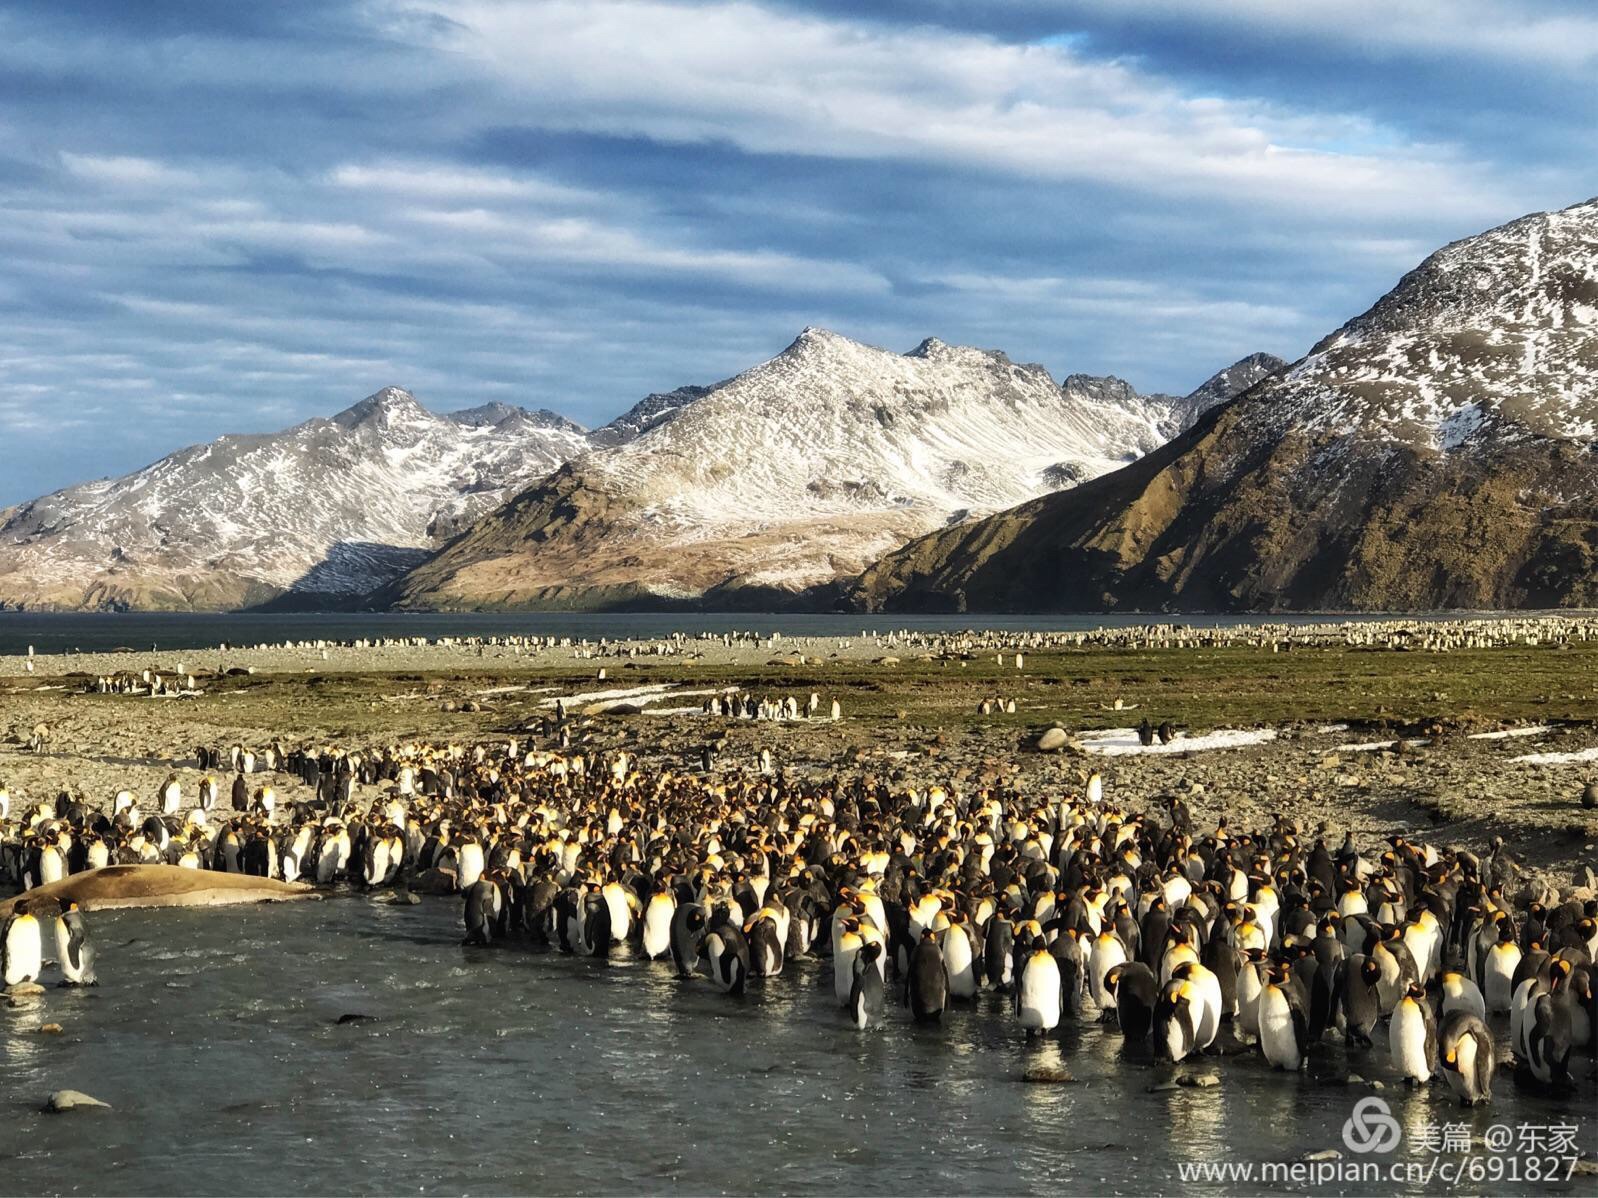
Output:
382 327 1278 609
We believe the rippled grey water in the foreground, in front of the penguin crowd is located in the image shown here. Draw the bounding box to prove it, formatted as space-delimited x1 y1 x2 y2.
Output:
0 898 1598 1195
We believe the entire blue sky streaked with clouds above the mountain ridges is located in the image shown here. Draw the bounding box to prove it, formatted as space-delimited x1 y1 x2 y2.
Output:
0 0 1598 503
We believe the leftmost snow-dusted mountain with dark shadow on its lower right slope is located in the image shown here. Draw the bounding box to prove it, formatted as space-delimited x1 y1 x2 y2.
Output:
0 387 588 610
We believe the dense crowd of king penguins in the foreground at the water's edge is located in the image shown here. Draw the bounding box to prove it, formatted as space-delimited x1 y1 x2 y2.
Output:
0 741 1598 1104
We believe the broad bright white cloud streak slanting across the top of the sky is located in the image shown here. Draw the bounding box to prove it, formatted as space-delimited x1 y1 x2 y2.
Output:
444 0 1502 219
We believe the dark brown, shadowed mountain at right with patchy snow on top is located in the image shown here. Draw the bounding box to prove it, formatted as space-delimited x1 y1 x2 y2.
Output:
855 200 1598 612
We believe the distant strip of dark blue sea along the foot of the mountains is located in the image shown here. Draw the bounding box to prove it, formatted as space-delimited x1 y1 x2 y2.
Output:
0 612 1495 655
